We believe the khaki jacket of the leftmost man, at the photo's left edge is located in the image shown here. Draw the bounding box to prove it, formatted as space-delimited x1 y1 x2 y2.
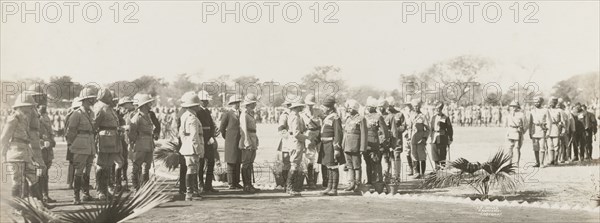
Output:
0 110 33 162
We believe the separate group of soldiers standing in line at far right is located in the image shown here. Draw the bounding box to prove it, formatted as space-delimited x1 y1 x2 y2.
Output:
506 97 600 167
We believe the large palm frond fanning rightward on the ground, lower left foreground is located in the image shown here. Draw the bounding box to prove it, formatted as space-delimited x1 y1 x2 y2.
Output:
60 179 170 223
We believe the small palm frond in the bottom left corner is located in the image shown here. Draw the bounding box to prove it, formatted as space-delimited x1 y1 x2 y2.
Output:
0 197 59 222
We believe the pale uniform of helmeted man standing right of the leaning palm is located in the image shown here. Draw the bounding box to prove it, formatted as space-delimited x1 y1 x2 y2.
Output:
179 110 204 174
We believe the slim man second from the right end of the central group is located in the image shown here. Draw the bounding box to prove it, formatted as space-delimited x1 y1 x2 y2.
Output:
406 98 429 179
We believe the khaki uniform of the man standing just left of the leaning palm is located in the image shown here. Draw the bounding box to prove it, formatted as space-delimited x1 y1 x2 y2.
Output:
127 110 154 188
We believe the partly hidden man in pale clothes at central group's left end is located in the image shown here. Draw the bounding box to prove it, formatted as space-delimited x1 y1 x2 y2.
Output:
277 100 292 190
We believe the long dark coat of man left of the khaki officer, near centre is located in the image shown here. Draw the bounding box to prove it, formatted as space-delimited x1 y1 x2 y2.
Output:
219 109 241 163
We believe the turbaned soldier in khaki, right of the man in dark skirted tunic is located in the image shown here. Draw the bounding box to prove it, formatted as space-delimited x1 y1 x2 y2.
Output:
342 100 367 191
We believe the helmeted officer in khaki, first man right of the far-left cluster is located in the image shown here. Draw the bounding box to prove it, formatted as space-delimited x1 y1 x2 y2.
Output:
66 88 97 204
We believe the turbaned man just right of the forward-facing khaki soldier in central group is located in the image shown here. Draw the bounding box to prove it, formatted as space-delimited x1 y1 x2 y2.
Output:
363 97 390 185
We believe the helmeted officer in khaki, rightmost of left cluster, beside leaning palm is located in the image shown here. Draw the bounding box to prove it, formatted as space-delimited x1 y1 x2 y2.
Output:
127 93 154 190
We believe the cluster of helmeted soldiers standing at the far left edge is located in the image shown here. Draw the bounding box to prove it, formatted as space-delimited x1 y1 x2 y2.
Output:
0 85 56 205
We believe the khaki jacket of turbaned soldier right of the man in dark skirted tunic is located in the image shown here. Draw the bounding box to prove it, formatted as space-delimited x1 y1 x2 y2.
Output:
342 114 367 153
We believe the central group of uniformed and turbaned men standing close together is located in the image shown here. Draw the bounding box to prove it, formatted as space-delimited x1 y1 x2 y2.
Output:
278 95 453 196
